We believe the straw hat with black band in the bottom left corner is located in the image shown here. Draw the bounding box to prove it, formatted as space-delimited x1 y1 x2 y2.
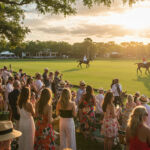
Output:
0 121 22 141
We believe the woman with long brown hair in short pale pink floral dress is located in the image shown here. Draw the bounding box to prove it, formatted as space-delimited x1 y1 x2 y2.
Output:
101 92 119 150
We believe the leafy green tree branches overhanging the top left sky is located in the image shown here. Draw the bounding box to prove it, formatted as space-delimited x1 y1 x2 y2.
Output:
0 0 142 46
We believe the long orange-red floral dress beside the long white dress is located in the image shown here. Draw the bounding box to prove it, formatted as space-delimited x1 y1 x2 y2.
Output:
34 115 55 150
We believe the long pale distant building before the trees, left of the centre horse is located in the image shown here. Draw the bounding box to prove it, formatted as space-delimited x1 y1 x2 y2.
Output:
22 50 58 58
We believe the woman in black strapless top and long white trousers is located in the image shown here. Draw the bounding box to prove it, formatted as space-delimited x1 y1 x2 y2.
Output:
56 88 76 150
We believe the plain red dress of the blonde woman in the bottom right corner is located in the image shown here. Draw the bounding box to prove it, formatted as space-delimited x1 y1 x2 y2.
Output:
129 136 150 150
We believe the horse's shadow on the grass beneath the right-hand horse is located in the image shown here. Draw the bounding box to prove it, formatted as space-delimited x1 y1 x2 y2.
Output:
137 75 150 90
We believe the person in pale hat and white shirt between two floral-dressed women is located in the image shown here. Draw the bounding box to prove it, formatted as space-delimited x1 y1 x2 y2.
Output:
96 88 104 114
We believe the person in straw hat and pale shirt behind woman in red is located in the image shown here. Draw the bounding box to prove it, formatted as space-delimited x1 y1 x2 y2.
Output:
140 95 150 127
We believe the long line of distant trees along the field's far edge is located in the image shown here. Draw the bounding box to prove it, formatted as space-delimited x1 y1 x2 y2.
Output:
0 38 150 59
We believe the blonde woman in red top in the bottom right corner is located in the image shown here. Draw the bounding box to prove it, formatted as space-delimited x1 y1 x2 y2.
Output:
126 106 150 150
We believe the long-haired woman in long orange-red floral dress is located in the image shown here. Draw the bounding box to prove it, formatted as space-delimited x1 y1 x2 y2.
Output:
34 88 55 150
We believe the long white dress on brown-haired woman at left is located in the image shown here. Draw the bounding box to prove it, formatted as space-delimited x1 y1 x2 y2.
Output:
19 108 35 150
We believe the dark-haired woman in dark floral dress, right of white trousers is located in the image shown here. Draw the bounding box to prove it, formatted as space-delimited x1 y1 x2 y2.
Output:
79 86 96 137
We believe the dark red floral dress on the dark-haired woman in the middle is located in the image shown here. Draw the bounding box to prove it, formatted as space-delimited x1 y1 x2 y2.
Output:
80 96 95 132
